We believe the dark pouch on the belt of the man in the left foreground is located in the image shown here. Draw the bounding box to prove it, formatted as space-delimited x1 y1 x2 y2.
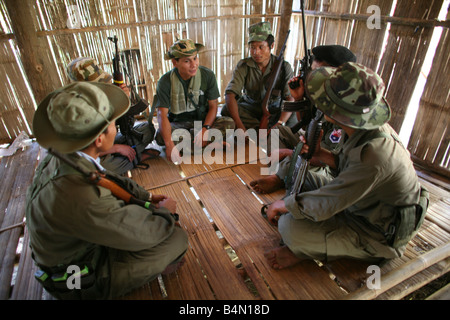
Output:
34 262 96 300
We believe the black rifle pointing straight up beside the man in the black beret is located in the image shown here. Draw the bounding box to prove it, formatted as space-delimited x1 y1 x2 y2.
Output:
281 0 315 133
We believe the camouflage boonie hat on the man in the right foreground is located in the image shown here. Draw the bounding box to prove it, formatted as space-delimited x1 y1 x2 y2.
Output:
306 62 391 130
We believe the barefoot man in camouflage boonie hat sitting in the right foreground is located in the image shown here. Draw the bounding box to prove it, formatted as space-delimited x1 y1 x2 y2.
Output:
255 62 427 269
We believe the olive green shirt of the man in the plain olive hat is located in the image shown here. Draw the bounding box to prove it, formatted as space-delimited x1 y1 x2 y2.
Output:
26 154 175 268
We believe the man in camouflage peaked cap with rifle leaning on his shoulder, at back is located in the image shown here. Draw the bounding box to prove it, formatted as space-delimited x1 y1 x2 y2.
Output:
222 22 297 131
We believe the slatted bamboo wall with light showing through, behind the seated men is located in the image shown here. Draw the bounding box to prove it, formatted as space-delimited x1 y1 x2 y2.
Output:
0 0 450 177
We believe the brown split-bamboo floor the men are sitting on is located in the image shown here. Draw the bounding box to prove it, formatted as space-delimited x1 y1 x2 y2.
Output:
0 143 450 300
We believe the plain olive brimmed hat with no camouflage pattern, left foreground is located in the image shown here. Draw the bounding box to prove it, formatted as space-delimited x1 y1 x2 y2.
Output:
33 82 130 153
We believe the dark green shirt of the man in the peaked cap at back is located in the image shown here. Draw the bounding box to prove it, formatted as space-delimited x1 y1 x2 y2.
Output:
225 54 294 118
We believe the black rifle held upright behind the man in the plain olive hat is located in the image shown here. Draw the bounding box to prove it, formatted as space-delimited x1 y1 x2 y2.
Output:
108 35 148 168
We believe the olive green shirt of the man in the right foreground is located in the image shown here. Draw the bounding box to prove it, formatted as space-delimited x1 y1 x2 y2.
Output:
284 124 420 233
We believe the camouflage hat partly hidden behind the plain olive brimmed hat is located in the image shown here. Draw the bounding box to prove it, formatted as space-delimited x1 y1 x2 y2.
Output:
66 57 112 83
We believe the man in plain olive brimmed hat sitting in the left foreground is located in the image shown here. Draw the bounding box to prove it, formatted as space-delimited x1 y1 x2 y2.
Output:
26 82 187 299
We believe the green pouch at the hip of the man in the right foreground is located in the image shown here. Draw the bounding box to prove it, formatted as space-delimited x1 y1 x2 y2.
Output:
386 186 429 248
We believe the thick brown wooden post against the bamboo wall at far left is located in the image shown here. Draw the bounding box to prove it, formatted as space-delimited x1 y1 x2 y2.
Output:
5 0 61 103
